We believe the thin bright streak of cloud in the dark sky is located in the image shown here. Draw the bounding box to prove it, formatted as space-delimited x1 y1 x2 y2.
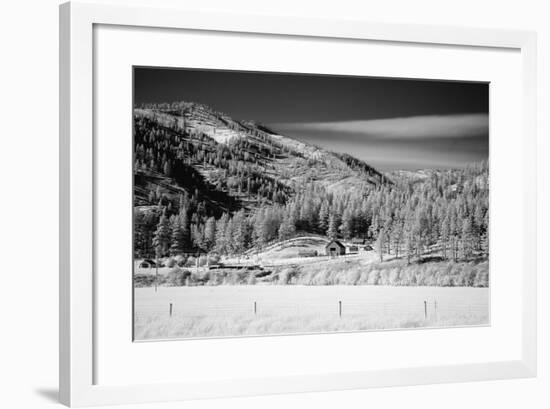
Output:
270 114 489 140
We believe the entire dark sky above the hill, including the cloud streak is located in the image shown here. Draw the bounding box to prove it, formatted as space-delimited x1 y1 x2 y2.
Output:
134 68 489 170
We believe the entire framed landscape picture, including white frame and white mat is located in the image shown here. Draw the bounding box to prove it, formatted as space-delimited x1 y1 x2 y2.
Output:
60 2 536 406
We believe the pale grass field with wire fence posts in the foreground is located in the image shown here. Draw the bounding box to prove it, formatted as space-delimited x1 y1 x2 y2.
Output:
134 285 489 340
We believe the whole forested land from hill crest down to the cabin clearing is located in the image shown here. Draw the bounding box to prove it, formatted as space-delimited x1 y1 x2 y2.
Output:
134 105 489 262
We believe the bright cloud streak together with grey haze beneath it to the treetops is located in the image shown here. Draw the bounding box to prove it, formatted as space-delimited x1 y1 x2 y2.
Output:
268 114 489 170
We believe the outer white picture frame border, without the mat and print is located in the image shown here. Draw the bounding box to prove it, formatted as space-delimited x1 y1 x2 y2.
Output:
59 2 537 406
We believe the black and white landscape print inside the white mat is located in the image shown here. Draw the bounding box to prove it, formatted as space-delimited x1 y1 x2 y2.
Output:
132 67 490 341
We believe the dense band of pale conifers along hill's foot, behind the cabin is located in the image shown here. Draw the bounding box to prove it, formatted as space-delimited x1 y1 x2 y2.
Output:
135 163 489 261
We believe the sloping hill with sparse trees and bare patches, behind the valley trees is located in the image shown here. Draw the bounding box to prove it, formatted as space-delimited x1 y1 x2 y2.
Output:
134 102 385 217
